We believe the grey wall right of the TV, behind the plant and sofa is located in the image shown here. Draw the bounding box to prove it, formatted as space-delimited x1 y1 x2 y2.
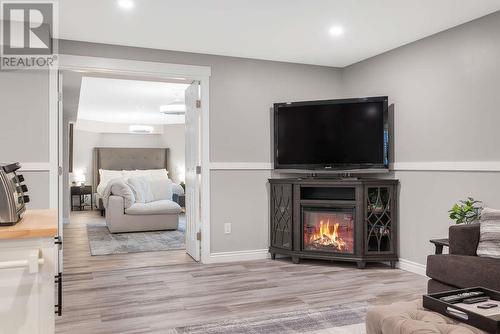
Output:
342 12 500 264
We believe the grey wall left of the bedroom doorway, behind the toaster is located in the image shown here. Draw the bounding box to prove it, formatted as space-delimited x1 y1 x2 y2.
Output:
0 70 49 208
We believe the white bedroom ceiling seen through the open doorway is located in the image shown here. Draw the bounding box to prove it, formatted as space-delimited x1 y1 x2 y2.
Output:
78 76 188 125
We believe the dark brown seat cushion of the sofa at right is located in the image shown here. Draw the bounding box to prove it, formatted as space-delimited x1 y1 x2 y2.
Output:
427 254 500 290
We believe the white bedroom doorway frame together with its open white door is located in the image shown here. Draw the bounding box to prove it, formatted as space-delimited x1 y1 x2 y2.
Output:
51 55 210 271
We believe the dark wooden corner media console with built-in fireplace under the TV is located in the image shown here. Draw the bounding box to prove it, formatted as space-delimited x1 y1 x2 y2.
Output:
269 178 399 268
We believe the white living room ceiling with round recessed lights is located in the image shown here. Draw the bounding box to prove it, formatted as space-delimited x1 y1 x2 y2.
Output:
59 0 500 67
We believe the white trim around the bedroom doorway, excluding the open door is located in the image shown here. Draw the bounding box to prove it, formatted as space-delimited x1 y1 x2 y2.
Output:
50 54 212 263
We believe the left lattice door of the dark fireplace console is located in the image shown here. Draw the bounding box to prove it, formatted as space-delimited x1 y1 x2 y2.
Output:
271 183 293 249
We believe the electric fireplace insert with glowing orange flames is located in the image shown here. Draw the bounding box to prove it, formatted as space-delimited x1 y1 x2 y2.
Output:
302 208 354 254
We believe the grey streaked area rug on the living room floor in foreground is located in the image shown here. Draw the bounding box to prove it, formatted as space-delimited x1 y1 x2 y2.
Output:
176 303 368 334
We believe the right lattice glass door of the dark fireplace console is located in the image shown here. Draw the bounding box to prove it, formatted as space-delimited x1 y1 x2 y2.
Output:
365 185 396 254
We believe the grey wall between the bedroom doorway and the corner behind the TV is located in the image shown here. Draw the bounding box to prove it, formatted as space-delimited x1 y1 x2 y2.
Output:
60 41 341 252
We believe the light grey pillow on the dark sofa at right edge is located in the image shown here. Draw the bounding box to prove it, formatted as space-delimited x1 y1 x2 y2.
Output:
477 208 500 259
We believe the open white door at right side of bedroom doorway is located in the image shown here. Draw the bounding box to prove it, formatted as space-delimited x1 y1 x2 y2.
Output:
186 81 201 261
